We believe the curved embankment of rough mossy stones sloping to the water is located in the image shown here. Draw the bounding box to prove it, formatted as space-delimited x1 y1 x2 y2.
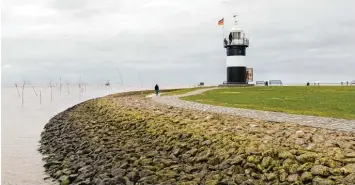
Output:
39 91 355 185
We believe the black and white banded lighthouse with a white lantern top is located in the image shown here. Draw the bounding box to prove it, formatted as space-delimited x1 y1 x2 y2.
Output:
224 15 249 84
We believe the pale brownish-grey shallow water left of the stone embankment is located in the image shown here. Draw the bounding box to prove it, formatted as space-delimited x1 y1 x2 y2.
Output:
1 86 139 185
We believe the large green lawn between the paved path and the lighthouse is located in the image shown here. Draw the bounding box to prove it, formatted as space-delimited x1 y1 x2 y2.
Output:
182 86 355 119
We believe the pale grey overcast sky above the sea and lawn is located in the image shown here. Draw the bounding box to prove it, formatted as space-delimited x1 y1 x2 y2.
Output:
1 0 355 85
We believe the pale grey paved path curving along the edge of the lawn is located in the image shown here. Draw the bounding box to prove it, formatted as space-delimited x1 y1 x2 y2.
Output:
151 88 355 132
